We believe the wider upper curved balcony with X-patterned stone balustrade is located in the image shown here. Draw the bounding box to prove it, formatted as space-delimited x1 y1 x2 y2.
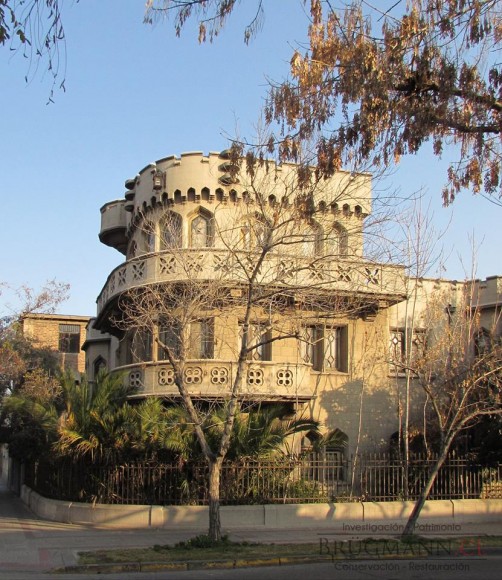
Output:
97 248 405 318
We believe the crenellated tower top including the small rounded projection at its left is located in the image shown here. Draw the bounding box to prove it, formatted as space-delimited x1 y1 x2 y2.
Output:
99 151 371 253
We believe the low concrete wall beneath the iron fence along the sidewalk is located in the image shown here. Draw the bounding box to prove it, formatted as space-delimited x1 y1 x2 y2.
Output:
21 485 502 532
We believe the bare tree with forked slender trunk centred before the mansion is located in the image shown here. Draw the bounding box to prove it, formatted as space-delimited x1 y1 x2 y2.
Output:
106 148 397 540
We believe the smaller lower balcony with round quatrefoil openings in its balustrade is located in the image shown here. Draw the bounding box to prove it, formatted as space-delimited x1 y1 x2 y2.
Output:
118 360 313 401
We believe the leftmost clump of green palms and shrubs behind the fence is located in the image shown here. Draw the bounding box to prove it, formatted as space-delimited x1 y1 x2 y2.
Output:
4 371 147 460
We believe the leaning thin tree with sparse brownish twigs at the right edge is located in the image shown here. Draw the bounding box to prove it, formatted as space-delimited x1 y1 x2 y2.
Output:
403 281 502 536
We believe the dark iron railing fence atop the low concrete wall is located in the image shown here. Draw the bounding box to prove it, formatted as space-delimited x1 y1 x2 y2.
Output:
25 454 502 505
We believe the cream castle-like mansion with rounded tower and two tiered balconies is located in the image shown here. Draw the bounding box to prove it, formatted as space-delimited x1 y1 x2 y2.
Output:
84 152 502 458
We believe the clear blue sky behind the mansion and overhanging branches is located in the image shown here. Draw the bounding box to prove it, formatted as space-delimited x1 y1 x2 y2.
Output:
0 0 502 315
